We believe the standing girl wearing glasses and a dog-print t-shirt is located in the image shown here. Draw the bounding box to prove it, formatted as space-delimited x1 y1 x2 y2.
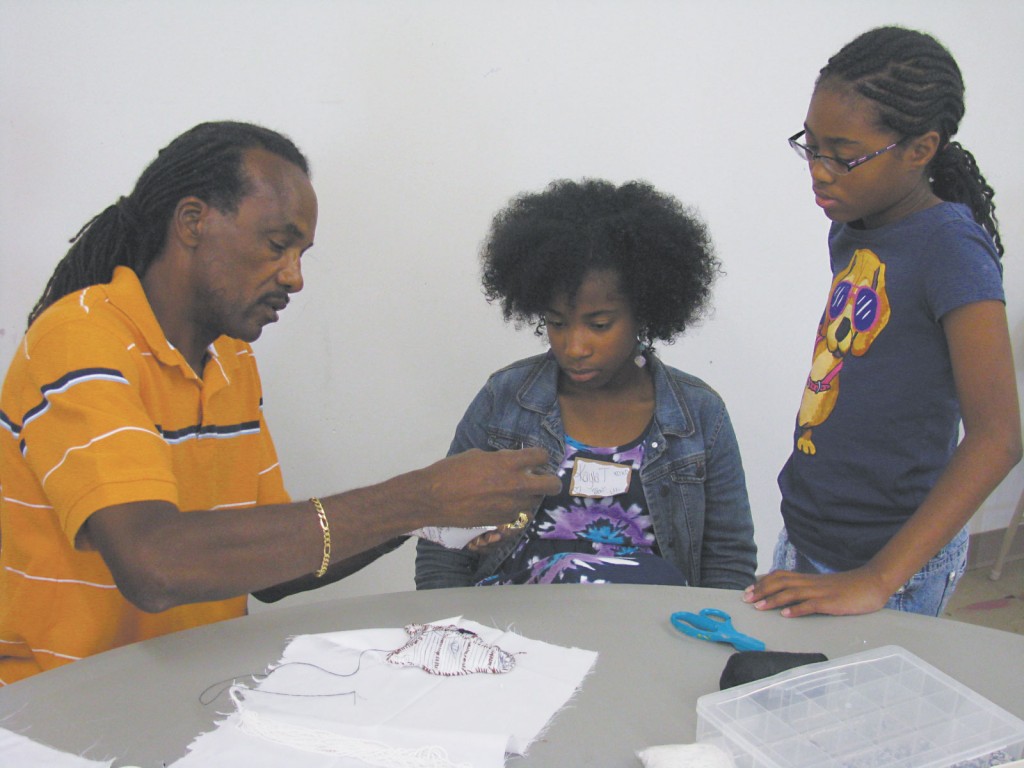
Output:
744 27 1021 616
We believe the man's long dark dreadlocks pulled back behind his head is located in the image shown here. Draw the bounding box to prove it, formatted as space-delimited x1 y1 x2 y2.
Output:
29 121 309 326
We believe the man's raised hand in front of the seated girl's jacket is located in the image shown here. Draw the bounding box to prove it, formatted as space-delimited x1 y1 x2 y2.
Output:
426 447 561 527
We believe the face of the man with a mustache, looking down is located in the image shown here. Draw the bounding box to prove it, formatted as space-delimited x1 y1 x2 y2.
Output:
193 150 316 342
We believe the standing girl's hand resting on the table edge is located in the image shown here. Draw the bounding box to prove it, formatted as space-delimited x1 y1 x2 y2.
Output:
743 568 890 618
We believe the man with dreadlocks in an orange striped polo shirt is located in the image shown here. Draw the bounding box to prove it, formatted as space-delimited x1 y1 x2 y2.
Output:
0 122 559 684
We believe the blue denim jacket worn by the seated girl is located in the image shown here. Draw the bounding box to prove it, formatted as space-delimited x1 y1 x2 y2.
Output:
416 354 757 589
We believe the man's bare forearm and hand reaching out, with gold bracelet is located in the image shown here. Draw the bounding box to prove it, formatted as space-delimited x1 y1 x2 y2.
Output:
79 449 560 611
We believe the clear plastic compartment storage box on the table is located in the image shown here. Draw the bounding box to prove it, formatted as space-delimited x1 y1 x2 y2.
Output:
696 645 1024 768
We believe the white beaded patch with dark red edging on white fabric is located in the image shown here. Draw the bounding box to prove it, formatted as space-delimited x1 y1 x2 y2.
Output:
385 624 515 677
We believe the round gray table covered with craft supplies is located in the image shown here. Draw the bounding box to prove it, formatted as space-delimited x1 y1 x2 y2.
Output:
0 585 1024 768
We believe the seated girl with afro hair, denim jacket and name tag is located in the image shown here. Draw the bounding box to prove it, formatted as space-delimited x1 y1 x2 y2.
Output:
416 180 757 590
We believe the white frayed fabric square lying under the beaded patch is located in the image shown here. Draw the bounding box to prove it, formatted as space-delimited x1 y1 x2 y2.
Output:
173 616 597 768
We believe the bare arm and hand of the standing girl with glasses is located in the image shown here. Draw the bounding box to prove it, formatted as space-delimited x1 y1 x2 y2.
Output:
743 301 1021 616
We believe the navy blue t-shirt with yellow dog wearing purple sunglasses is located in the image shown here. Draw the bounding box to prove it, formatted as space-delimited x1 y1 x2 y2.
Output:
778 203 1005 570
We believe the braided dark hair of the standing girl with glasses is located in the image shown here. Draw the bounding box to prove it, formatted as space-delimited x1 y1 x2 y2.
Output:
815 27 1004 257
